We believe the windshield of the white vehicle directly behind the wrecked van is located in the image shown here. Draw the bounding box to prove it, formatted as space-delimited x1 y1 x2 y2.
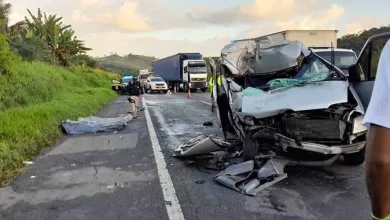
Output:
316 51 357 69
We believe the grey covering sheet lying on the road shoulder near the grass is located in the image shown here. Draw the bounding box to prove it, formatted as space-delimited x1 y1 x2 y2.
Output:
62 114 133 135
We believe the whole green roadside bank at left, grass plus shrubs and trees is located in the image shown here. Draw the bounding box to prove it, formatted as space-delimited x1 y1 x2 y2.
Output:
0 0 119 186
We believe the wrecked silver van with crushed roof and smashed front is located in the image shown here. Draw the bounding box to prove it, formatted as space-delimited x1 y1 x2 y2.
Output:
210 33 390 165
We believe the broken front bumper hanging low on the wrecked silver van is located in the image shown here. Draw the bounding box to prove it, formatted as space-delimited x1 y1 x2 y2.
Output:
274 134 366 155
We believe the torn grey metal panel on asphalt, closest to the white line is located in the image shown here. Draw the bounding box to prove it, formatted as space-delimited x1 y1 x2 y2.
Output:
173 135 221 157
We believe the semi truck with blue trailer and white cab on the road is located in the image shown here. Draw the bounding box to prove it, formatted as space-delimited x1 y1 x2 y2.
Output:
153 53 207 92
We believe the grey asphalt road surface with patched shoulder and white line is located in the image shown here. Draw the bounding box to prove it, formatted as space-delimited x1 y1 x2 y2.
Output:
0 93 370 220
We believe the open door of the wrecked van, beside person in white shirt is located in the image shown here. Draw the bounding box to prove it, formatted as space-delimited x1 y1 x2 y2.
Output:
349 32 390 111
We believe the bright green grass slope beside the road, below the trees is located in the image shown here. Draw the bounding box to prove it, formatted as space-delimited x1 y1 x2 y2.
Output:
0 62 118 185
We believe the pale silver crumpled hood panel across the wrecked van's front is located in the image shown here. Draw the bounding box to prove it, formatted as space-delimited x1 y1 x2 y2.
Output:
241 81 348 118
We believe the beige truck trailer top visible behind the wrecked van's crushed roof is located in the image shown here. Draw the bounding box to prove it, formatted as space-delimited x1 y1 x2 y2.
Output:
237 30 338 48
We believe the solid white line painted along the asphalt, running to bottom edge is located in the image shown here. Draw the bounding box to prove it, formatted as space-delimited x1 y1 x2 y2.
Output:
142 97 184 220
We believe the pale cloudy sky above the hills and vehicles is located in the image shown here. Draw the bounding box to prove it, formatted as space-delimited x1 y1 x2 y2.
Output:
8 0 390 58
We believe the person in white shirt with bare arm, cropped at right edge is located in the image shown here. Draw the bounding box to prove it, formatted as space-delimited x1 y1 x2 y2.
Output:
363 41 390 220
